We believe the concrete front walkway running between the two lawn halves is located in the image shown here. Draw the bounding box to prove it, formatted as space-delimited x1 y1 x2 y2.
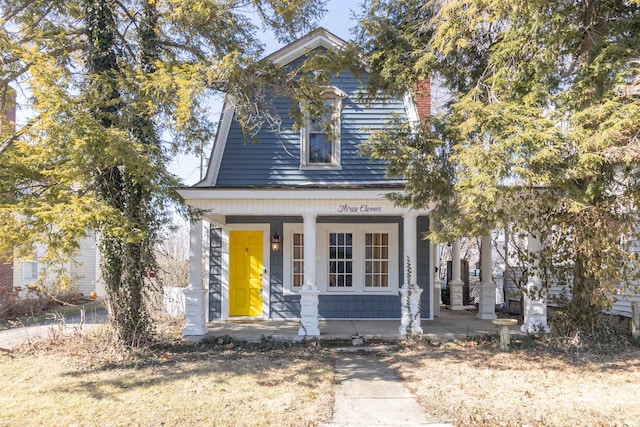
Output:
325 353 452 427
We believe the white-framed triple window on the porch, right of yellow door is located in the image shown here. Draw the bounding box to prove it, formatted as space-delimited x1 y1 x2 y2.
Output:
283 223 402 295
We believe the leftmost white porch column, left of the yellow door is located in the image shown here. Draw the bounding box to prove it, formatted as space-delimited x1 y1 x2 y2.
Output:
182 219 207 337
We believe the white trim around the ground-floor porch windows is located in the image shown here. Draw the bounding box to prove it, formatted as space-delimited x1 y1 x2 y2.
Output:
282 223 400 295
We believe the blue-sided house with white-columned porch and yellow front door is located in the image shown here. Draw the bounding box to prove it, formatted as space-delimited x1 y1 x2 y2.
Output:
180 28 495 336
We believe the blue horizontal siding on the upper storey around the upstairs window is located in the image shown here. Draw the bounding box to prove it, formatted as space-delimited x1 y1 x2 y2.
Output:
216 67 405 187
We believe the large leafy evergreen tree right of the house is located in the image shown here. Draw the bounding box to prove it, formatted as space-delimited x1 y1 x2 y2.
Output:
357 0 640 333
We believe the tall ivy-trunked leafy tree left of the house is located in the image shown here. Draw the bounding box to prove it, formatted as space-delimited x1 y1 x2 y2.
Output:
0 0 324 346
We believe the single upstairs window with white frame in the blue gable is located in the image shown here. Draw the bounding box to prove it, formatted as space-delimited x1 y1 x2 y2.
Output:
300 86 347 169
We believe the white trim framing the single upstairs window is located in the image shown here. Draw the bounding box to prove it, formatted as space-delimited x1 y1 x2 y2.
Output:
300 86 347 170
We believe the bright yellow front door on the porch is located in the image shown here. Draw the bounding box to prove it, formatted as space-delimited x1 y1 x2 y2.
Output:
229 231 264 317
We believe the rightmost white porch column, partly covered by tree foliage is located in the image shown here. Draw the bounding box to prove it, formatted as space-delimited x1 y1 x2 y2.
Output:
520 234 549 333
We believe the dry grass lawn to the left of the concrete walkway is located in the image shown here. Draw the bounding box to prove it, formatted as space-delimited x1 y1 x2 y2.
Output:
0 324 333 426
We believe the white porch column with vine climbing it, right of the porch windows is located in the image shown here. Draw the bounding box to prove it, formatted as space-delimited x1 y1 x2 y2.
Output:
399 212 422 335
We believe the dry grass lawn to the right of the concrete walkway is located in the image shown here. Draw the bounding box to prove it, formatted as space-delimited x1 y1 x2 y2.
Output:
390 340 640 426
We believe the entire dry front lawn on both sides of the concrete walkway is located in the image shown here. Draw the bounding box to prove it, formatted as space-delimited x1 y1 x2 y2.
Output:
0 325 640 426
